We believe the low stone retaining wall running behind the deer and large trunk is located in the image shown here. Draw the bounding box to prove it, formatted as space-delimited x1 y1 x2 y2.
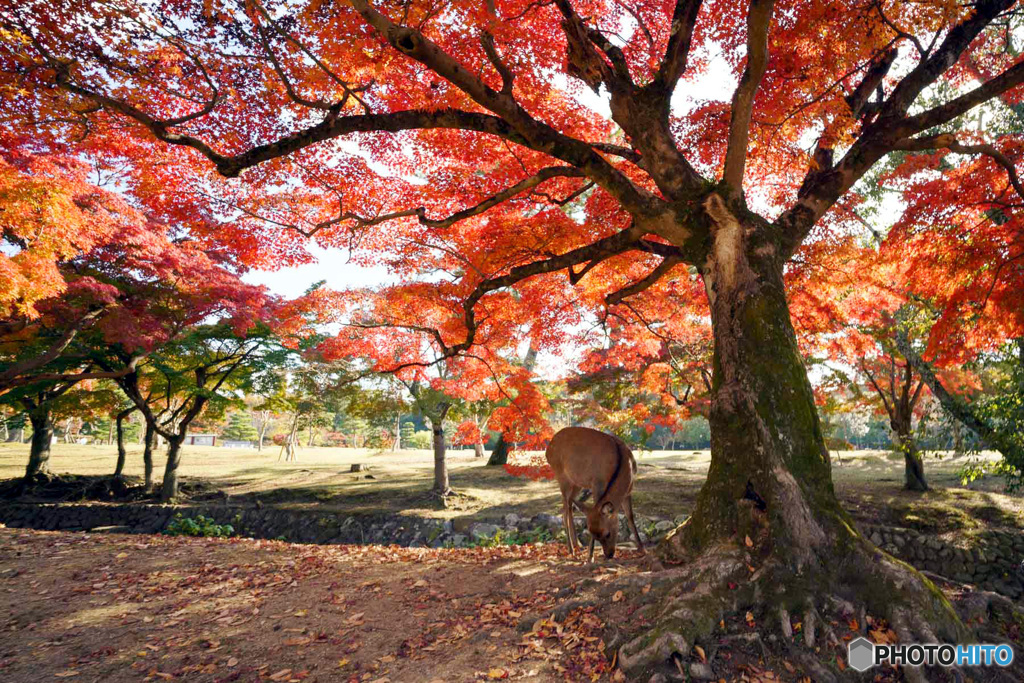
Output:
0 503 1024 599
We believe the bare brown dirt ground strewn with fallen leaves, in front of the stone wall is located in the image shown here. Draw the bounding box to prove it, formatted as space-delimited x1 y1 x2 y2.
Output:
0 528 638 683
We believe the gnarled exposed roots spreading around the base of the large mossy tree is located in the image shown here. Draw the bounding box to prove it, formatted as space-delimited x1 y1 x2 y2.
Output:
572 524 1024 683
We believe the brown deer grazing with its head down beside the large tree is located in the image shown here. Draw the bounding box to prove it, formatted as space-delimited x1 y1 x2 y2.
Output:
545 427 644 562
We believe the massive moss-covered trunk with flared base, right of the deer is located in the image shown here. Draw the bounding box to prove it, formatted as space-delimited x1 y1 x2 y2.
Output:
643 201 965 670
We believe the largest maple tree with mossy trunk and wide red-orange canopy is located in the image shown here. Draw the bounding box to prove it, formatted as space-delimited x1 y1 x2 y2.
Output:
6 0 1024 658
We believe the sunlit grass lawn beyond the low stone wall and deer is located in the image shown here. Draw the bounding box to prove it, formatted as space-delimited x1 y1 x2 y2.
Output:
0 443 1024 532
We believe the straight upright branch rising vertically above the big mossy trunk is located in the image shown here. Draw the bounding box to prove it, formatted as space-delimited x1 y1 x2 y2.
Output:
722 0 775 197
